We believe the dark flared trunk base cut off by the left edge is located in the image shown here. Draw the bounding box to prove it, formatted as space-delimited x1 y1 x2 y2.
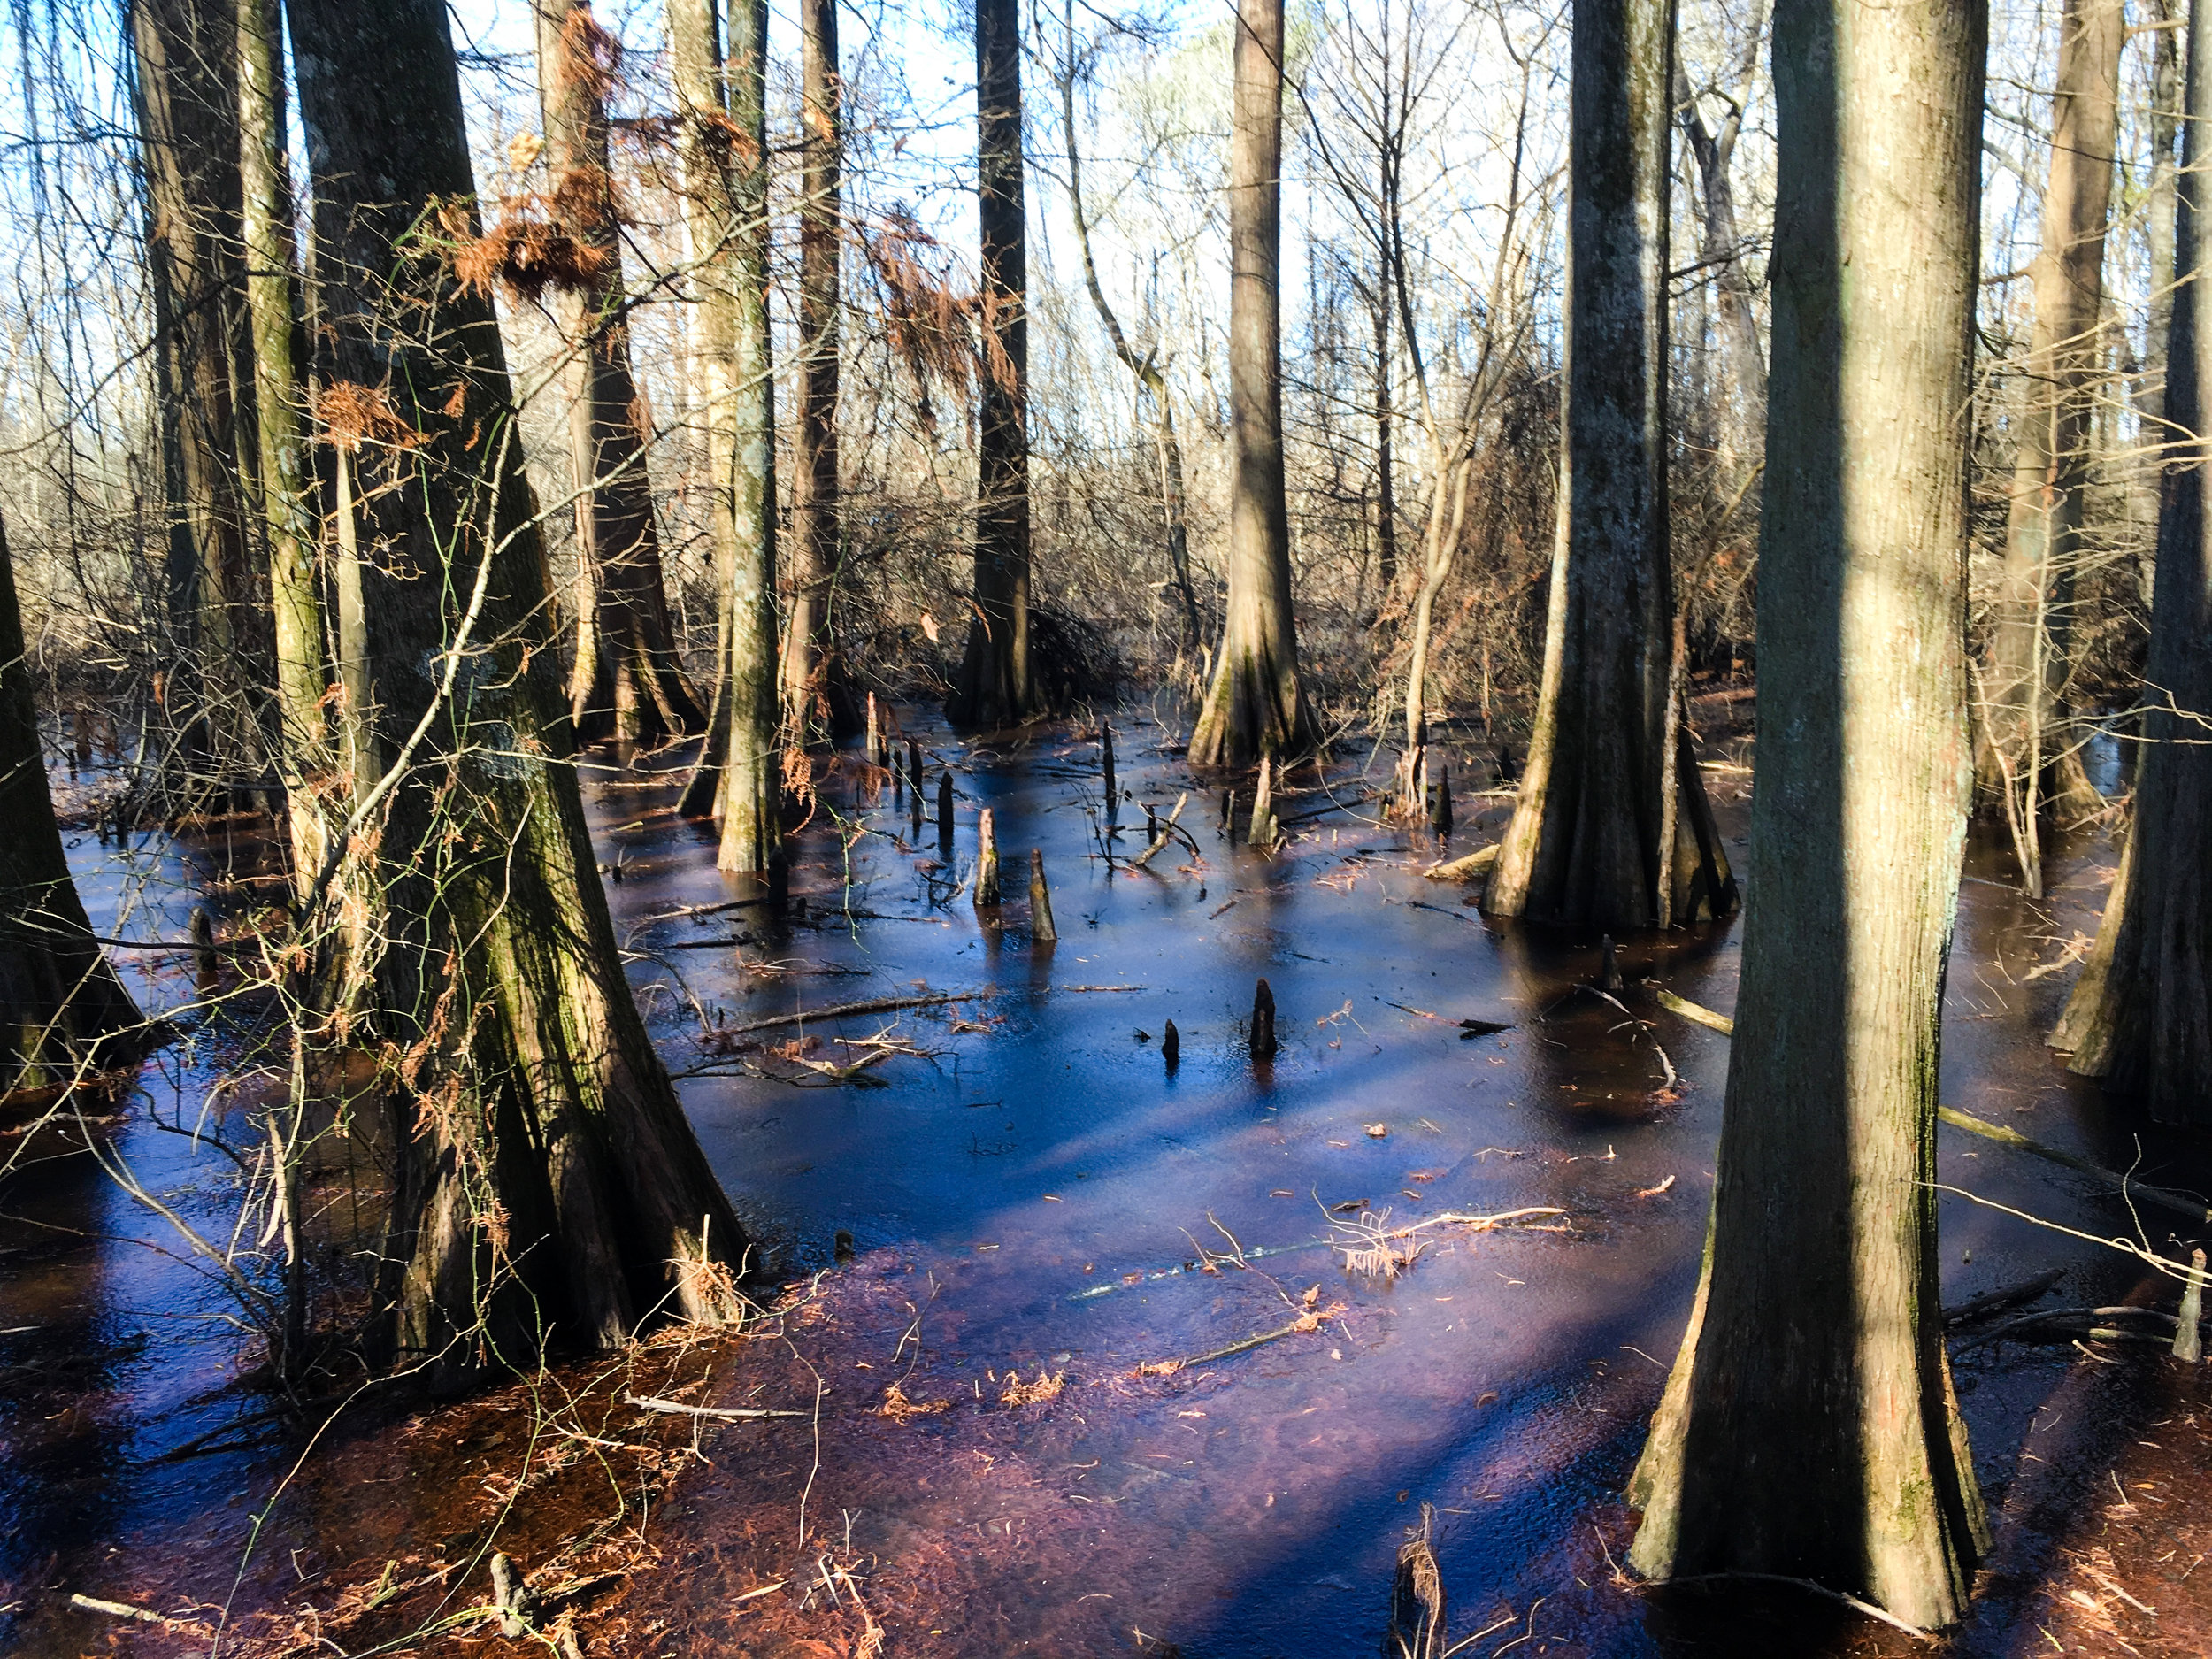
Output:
0 513 146 1100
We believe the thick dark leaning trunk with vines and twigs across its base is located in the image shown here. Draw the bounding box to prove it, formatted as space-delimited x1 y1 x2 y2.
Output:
292 0 746 1389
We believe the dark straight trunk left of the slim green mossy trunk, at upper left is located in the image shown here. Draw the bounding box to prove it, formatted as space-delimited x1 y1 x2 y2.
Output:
131 0 265 781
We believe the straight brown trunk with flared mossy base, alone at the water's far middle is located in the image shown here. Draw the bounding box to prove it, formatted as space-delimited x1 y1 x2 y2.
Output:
1190 0 1321 765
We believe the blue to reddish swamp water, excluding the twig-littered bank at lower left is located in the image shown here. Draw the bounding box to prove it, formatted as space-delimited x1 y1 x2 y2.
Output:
0 717 2201 1659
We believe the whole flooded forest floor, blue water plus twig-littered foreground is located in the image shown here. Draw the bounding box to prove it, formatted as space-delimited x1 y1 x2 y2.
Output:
0 706 2212 1659
